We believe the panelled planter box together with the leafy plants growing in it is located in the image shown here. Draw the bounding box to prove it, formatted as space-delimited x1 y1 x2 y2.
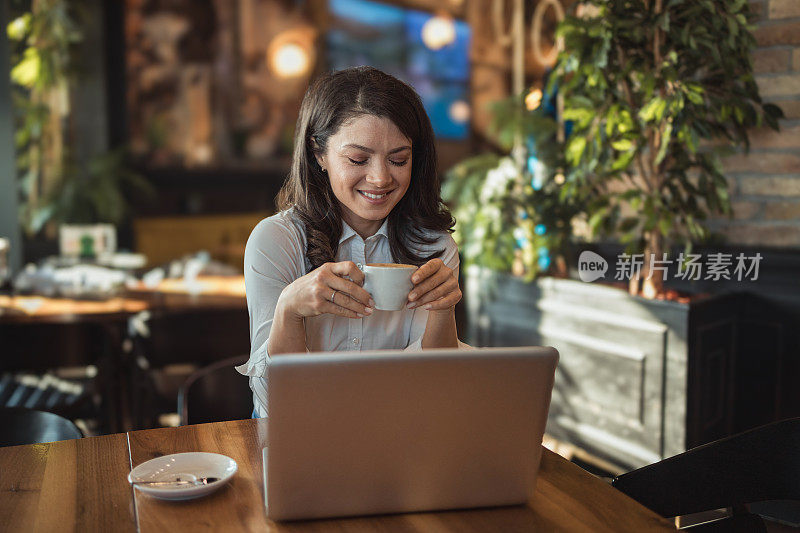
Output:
446 0 785 469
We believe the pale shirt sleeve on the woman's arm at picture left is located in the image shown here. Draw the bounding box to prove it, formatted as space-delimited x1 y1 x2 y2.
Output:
236 215 305 378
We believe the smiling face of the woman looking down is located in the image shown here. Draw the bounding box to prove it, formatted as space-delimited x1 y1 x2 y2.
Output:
317 115 411 238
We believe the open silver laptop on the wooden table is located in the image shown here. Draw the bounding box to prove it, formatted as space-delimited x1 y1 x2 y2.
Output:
264 347 558 520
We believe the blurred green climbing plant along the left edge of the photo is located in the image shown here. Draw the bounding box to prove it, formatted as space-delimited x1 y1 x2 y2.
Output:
6 0 153 235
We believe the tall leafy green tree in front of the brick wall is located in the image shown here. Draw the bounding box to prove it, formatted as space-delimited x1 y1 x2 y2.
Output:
550 0 782 296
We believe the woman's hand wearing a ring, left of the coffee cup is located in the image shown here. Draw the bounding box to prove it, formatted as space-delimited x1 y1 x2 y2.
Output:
278 261 375 319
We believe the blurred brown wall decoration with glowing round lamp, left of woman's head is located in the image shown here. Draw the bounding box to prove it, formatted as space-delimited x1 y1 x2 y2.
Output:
125 0 317 168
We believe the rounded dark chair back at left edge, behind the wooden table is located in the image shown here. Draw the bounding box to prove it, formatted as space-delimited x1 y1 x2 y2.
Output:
0 407 83 446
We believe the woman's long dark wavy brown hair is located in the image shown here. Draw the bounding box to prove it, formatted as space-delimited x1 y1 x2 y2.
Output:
277 67 455 269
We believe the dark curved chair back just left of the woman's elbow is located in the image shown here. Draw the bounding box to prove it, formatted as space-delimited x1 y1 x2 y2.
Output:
178 356 253 426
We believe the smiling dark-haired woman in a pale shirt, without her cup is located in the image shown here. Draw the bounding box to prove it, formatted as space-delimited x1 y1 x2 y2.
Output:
238 67 461 417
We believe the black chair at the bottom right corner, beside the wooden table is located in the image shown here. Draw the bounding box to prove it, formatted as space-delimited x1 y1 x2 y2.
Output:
612 418 800 532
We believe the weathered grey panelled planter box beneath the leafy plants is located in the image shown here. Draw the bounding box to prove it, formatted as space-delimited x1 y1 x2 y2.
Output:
464 268 782 468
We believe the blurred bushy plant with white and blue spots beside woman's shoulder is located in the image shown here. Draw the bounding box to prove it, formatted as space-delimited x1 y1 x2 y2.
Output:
442 95 578 280
